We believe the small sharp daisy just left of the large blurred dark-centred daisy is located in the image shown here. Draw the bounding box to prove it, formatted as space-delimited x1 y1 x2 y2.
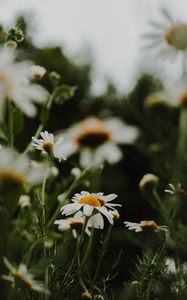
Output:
32 131 66 161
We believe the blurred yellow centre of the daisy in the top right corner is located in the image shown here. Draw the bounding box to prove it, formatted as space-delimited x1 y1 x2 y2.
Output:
164 24 187 51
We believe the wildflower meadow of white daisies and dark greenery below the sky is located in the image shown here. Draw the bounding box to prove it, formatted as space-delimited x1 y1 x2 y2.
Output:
0 9 187 300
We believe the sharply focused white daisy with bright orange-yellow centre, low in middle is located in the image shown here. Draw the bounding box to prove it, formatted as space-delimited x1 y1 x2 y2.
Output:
61 191 121 229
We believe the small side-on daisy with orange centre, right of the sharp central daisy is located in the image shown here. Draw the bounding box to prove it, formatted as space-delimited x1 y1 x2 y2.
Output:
124 220 167 232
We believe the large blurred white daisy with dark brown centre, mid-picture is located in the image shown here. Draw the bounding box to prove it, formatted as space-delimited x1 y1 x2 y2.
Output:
55 117 138 167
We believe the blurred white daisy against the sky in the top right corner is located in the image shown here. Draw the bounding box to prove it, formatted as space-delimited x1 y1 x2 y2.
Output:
143 9 187 62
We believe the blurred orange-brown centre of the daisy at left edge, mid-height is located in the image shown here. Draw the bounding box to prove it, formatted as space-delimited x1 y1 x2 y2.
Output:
0 170 27 188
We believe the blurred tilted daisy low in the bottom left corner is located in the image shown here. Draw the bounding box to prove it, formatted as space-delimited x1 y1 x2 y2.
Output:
1 258 49 294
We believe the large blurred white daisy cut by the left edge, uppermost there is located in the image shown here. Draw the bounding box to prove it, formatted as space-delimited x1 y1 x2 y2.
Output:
0 48 48 117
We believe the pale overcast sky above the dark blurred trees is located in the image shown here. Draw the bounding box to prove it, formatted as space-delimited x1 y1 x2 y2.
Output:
0 0 187 93
